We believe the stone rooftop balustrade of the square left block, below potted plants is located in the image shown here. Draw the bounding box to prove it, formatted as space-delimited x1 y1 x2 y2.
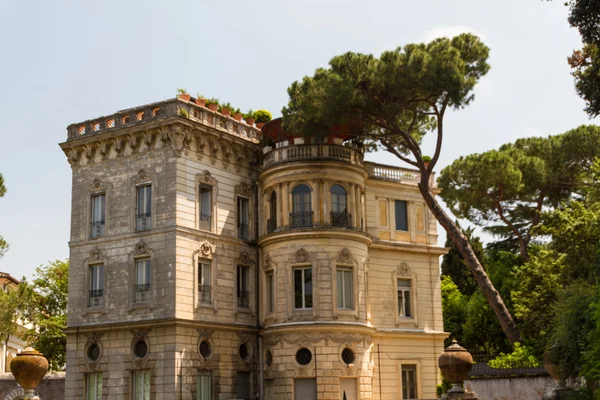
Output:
67 98 261 143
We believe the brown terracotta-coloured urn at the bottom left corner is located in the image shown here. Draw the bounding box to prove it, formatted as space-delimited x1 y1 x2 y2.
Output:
10 347 48 399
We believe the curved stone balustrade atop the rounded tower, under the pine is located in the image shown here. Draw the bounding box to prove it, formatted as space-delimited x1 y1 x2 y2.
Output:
263 144 363 167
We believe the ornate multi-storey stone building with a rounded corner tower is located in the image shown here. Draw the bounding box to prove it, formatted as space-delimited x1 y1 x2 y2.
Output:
61 98 447 400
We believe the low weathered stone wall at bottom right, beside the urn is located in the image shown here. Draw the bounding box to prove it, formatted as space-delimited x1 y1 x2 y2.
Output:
465 376 556 400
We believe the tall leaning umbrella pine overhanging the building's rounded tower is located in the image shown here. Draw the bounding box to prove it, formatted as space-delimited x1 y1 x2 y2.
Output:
282 34 520 342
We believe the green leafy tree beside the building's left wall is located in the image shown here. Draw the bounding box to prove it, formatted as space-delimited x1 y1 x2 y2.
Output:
18 260 69 370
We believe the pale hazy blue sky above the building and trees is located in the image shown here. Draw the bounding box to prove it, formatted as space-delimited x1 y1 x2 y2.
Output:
0 0 598 277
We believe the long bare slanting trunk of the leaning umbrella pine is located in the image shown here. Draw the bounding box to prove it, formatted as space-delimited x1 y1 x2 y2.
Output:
419 177 521 344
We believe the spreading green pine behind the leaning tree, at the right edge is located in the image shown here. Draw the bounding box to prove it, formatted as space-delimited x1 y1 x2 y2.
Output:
439 126 600 261
